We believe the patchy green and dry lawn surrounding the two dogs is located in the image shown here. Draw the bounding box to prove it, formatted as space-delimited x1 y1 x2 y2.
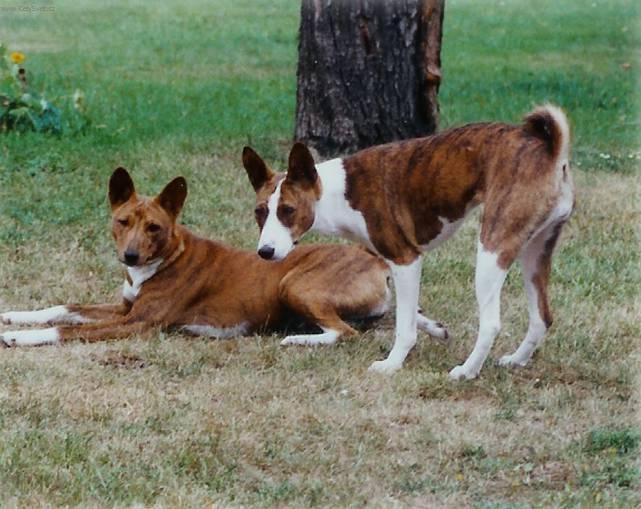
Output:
0 0 641 509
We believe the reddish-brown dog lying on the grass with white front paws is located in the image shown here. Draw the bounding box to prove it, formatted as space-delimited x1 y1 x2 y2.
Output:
0 168 390 346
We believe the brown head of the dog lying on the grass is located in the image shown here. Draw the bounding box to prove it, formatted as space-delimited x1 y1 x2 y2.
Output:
109 168 187 267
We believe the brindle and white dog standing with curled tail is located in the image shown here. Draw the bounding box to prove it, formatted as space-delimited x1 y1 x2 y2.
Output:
243 105 574 380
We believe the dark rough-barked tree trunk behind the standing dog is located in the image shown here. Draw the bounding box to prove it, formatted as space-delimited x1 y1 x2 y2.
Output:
294 0 444 156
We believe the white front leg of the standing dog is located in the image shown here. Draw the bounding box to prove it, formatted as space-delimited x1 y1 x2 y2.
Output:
369 256 423 374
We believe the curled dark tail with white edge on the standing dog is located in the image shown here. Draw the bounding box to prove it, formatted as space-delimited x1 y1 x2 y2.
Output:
523 104 570 161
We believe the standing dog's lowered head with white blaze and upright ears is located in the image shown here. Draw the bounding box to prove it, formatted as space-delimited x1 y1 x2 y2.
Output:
243 143 321 260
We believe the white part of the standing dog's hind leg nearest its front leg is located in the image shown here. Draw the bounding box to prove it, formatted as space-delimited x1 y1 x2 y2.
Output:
449 240 507 380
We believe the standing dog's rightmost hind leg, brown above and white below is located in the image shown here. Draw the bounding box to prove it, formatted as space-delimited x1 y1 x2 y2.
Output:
499 226 561 367
